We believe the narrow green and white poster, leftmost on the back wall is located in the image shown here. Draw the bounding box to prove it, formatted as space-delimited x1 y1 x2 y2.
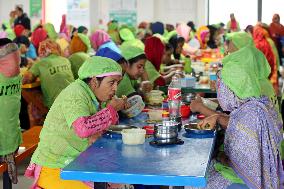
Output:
29 0 42 26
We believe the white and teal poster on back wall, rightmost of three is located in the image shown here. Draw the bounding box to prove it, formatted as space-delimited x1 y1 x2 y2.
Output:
109 0 137 26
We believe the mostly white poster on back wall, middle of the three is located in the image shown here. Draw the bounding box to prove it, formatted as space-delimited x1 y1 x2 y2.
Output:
67 0 90 27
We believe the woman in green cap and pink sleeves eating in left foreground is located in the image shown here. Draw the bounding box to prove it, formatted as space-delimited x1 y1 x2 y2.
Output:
25 56 127 189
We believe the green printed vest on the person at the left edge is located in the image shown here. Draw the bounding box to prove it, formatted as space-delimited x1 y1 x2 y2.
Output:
0 74 22 156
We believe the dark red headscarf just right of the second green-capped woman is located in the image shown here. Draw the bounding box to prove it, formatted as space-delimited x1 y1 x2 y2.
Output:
145 37 165 71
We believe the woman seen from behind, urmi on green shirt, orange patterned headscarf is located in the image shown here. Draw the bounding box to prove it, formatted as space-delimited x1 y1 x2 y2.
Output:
24 39 74 108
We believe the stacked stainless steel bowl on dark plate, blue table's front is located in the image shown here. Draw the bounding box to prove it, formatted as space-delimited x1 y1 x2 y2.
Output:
154 121 178 140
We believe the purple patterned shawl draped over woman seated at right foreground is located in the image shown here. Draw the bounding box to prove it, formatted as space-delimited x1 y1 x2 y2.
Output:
217 80 284 189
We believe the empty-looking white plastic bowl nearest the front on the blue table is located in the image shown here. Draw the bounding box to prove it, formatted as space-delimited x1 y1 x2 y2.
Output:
121 129 146 145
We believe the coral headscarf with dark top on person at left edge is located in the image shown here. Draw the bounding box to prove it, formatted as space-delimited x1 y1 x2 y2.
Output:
0 38 21 77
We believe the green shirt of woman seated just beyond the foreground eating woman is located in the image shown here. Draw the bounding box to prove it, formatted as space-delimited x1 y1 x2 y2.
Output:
116 73 137 98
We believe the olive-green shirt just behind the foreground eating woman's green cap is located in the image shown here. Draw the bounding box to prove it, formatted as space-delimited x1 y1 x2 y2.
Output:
68 52 90 79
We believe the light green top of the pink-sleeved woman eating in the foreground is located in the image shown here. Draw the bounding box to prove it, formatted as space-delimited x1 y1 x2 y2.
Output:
32 79 102 168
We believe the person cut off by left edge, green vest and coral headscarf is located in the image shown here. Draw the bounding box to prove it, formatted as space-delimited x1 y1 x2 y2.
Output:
0 38 22 184
